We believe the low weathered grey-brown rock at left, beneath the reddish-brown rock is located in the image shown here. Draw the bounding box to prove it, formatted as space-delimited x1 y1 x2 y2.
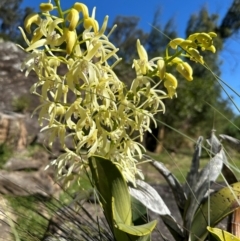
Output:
0 150 59 197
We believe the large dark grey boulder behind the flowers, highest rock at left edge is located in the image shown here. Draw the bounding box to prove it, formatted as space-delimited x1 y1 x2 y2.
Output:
0 42 38 111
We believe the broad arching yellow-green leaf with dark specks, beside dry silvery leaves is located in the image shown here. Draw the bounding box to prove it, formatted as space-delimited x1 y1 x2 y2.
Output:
190 182 240 241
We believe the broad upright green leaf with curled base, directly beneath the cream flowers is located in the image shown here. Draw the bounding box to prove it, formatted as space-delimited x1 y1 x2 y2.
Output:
90 156 157 241
